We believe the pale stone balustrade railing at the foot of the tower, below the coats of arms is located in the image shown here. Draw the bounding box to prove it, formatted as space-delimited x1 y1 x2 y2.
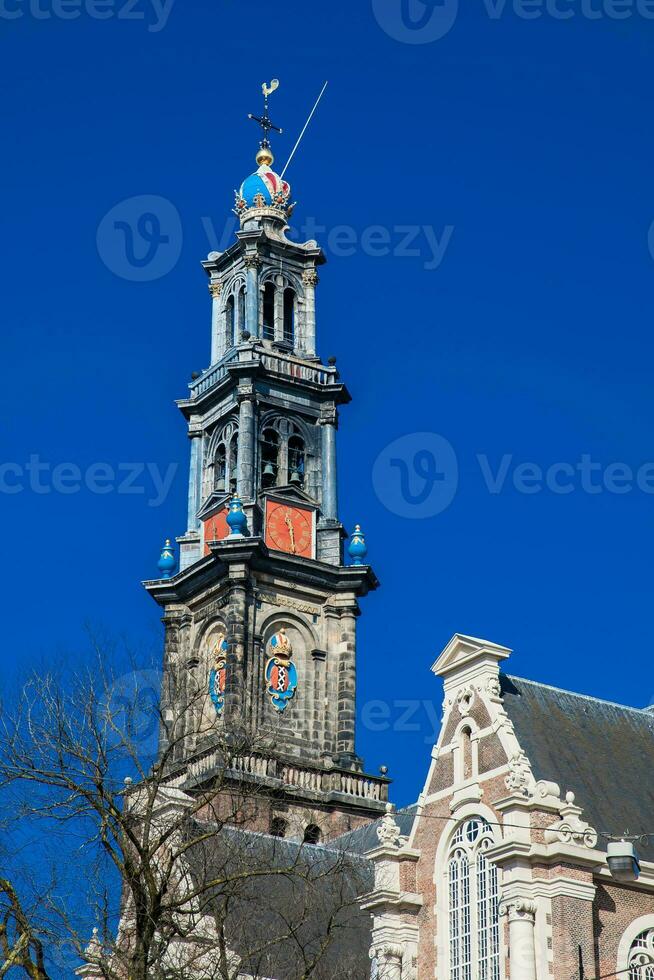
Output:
174 749 388 803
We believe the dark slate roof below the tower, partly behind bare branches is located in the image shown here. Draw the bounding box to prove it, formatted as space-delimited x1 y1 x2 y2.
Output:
186 821 374 980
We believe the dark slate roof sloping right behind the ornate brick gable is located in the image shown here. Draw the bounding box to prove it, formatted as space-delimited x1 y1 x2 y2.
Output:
501 675 654 861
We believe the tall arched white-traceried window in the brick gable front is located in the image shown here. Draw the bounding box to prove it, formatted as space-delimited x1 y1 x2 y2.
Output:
446 817 500 980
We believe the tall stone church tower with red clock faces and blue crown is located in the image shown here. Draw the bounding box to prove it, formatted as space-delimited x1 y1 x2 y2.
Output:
145 82 388 837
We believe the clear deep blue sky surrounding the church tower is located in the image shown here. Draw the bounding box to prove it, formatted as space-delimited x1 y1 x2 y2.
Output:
0 0 654 803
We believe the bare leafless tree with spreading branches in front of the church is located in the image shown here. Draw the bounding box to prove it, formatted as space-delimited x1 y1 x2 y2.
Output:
0 666 370 980
